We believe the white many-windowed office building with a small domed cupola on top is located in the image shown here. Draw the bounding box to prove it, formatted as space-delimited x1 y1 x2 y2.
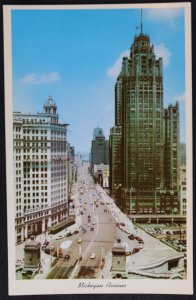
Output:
13 97 68 242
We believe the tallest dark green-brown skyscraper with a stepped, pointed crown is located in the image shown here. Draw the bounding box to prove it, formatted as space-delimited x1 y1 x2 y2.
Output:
110 24 179 213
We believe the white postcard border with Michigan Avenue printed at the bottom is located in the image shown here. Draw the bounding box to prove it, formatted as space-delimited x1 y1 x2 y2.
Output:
3 3 193 295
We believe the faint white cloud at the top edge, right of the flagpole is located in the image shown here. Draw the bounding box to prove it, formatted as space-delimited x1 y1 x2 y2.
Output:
145 8 182 24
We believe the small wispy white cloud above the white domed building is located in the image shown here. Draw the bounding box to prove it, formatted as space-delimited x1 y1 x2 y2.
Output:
20 72 60 84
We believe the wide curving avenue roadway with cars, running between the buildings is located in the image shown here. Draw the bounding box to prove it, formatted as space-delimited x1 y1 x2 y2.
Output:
47 165 123 278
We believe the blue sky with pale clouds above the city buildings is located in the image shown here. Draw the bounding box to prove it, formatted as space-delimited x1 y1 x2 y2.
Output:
12 9 185 152
